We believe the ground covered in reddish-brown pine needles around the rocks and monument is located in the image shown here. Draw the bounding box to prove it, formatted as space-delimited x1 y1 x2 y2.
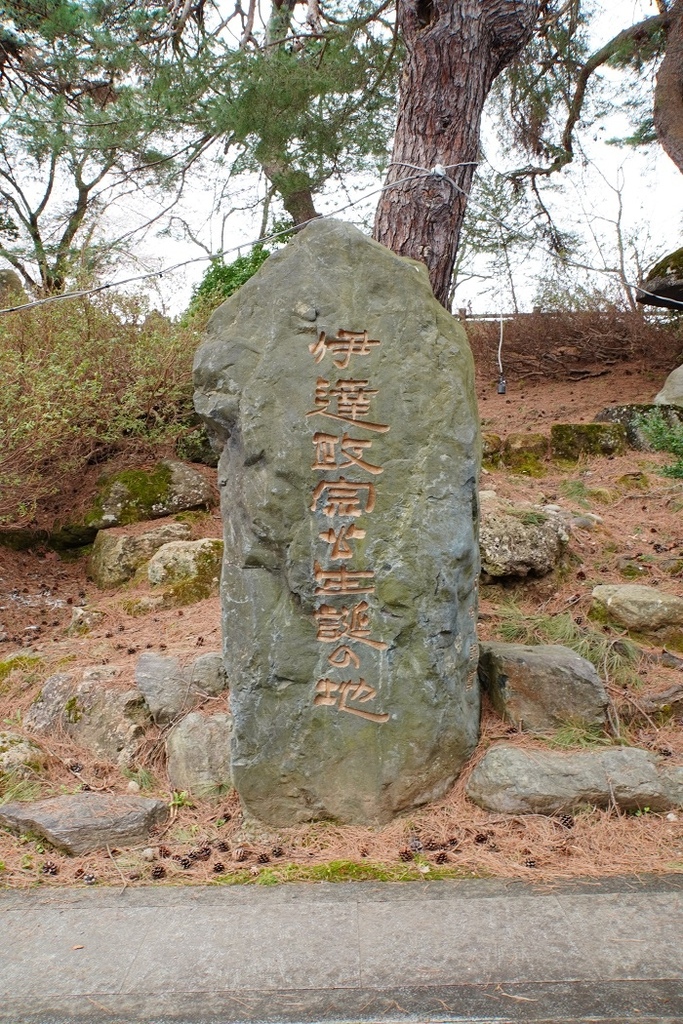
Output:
0 365 683 887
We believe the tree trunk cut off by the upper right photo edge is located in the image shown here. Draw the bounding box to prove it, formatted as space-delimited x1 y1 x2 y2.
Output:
654 0 683 173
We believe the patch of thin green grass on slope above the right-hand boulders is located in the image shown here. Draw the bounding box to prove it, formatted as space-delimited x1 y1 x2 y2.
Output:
497 605 640 686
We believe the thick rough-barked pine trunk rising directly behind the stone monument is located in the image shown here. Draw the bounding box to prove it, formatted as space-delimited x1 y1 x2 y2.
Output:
374 0 539 308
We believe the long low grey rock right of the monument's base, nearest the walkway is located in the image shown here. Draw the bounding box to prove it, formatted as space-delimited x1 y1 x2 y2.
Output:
467 744 683 814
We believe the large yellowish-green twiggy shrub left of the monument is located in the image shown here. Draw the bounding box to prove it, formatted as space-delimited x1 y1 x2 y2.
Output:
0 293 199 526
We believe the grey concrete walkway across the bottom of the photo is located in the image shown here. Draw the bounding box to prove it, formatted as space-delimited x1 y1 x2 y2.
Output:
0 876 683 1024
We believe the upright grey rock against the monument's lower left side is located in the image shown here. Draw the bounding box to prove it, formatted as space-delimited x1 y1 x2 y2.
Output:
166 712 232 799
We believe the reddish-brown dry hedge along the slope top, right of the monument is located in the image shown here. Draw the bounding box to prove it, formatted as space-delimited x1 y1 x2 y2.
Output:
466 307 683 380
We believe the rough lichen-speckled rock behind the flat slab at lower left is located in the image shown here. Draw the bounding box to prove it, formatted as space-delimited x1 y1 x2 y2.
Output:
24 666 151 767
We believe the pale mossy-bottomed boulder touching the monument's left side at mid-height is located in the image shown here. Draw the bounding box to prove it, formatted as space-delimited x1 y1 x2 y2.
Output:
147 538 223 604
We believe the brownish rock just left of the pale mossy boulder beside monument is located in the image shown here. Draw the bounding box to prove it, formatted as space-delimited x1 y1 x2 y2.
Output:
88 522 191 589
